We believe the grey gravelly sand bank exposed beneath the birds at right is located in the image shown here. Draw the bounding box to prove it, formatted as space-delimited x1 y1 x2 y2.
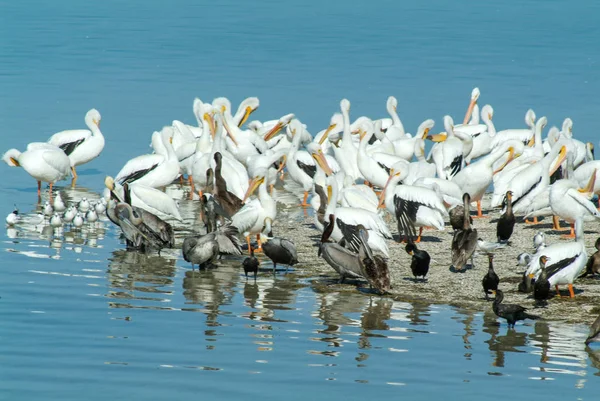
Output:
256 195 600 324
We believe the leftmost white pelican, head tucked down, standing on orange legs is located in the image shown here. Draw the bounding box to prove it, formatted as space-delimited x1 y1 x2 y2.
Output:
2 142 71 197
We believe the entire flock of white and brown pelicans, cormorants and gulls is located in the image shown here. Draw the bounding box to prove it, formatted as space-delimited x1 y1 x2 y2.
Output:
3 88 600 338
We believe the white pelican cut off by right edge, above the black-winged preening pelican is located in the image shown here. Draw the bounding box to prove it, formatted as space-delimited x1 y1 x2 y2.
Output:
550 170 600 238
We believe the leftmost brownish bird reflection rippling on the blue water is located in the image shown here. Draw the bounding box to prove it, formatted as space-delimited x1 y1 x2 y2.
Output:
107 249 176 309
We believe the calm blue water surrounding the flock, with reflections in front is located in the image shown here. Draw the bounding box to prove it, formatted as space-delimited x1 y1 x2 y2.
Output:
0 0 600 400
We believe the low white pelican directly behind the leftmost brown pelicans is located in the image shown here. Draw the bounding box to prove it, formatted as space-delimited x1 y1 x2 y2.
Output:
104 176 182 221
